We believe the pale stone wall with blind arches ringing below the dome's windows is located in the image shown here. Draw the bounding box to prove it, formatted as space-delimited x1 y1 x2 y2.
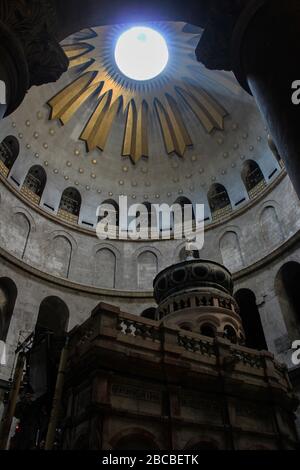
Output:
0 171 300 432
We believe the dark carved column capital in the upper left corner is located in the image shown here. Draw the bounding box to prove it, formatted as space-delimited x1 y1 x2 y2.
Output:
0 0 68 117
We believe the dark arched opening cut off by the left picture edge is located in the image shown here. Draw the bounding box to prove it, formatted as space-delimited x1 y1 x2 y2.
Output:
0 278 18 342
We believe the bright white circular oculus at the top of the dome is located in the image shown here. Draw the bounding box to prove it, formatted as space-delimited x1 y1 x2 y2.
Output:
115 26 169 81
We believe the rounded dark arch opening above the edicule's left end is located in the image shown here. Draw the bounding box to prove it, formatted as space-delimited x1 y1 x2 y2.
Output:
35 296 69 336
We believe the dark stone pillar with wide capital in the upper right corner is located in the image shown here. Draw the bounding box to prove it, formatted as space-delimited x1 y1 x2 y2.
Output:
197 0 300 197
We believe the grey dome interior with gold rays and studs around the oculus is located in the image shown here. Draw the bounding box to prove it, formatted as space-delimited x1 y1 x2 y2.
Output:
1 22 281 230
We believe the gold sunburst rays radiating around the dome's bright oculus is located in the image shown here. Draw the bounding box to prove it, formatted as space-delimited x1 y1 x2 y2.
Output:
48 22 229 163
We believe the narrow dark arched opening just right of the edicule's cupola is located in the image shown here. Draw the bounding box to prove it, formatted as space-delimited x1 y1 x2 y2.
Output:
234 289 268 350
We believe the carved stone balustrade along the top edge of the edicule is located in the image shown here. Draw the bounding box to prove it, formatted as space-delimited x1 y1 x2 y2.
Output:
70 304 291 390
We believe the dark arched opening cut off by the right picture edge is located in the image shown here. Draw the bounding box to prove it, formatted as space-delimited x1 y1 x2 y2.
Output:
275 261 300 340
